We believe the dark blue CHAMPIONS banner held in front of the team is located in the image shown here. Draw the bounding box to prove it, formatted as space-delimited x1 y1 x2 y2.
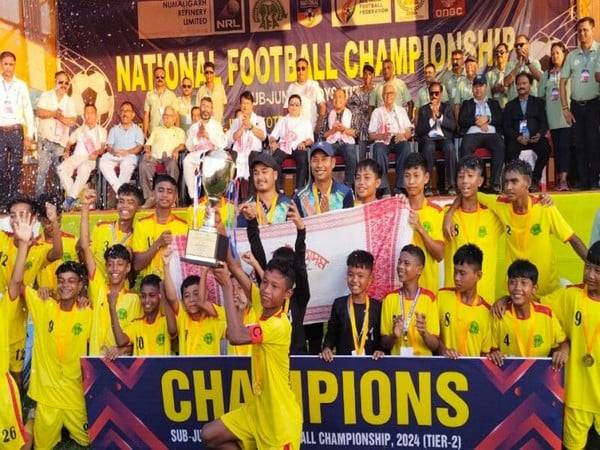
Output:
82 357 563 450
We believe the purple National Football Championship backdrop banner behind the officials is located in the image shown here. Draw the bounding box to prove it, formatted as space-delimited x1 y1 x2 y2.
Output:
57 0 576 129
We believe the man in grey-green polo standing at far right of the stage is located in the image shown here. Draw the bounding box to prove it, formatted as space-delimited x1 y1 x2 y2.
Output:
560 17 600 189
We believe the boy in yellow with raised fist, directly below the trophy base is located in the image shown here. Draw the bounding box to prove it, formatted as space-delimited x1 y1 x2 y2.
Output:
163 250 227 356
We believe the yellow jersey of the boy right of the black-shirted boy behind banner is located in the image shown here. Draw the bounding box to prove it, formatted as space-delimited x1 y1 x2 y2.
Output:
381 288 440 356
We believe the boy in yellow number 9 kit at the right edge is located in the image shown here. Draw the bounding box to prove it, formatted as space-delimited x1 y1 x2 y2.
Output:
541 241 600 450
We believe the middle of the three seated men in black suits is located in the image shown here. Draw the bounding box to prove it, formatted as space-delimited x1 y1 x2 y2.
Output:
458 75 504 193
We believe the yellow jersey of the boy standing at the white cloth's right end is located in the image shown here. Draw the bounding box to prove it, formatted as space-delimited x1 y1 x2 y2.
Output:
412 200 444 294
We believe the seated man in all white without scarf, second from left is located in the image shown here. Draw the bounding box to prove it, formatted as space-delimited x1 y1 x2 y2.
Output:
98 101 144 193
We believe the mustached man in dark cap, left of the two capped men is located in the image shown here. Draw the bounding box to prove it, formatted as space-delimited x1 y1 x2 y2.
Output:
237 152 291 227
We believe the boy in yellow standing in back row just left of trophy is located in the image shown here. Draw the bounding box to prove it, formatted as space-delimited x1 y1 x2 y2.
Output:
131 174 188 279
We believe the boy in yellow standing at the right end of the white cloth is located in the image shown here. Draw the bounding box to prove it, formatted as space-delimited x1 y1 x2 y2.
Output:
404 153 444 294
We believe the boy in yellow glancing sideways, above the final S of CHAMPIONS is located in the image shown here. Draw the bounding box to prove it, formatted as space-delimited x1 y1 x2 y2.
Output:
437 244 492 359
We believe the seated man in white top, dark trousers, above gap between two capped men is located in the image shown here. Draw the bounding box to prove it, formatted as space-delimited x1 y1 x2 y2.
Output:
269 94 314 190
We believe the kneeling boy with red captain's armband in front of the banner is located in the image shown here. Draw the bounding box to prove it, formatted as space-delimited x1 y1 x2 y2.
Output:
201 259 302 450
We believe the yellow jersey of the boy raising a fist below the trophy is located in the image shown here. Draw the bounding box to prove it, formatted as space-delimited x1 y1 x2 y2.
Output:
177 304 227 356
